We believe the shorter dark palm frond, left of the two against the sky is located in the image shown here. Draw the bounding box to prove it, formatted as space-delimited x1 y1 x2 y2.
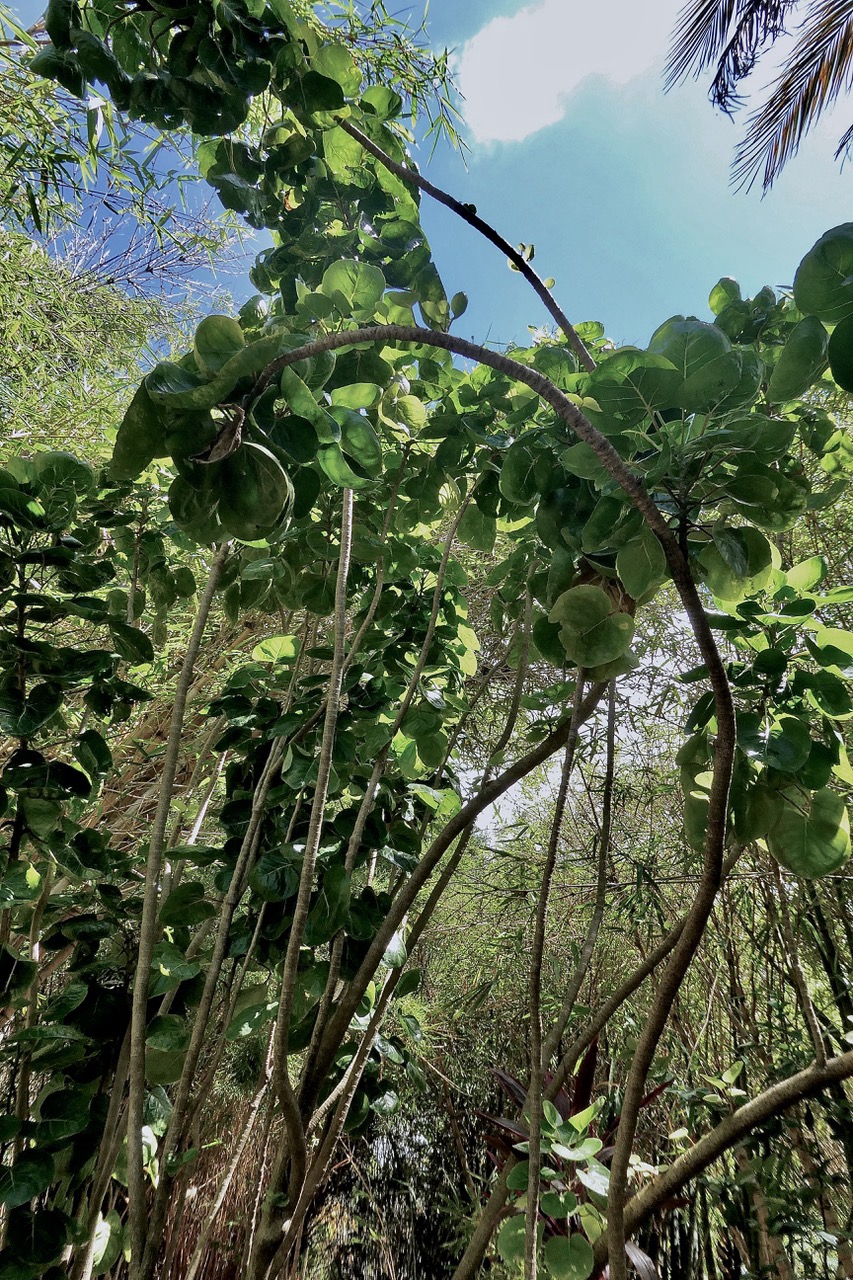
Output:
665 0 798 114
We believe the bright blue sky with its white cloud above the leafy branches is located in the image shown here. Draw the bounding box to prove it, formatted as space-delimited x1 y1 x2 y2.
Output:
13 0 853 344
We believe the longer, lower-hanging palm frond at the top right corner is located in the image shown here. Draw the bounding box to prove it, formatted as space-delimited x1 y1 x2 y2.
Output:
733 0 853 191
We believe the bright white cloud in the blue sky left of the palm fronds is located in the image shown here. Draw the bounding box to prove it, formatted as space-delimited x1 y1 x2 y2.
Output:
456 0 683 142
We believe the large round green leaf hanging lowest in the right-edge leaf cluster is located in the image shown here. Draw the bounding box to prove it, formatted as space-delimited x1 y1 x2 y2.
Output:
767 787 850 879
